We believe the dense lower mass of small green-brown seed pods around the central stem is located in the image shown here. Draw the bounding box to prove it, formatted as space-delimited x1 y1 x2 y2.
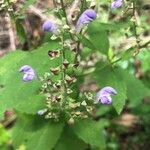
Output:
37 73 94 121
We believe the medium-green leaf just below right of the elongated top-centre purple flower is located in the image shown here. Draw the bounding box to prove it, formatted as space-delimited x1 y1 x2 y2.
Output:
88 21 109 55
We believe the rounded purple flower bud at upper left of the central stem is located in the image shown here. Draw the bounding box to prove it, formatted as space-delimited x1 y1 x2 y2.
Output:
42 20 57 32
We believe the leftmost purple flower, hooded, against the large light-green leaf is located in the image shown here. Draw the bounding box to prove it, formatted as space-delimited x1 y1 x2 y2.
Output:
19 65 36 81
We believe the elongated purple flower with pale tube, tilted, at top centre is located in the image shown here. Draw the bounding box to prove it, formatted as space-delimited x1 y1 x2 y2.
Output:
76 9 97 32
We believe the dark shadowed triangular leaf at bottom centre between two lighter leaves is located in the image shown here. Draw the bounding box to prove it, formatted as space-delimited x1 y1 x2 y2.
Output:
55 126 87 150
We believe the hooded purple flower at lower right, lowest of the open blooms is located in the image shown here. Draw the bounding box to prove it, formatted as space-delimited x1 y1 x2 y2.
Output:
96 86 117 104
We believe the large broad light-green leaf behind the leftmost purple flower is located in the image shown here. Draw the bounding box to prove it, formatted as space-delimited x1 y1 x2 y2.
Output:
0 42 61 117
